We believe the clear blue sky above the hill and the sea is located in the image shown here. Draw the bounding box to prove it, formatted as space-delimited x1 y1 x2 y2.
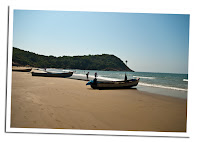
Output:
13 10 190 73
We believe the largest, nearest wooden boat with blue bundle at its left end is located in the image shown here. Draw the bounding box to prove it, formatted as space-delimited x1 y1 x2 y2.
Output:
86 78 140 89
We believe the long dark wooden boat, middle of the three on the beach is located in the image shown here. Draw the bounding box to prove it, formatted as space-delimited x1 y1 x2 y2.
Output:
32 72 73 77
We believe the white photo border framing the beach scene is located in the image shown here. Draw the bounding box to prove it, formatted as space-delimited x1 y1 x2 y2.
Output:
6 5 190 138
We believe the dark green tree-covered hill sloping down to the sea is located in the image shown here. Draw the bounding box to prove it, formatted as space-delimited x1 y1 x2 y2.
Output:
12 47 132 71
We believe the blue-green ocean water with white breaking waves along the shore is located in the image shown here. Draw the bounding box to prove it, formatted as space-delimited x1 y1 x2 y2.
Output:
43 69 188 99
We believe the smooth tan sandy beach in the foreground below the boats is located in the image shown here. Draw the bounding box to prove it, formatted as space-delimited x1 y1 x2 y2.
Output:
11 71 187 132
